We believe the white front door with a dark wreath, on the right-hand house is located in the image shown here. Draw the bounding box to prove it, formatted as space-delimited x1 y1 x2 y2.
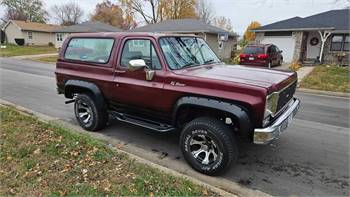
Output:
306 31 321 59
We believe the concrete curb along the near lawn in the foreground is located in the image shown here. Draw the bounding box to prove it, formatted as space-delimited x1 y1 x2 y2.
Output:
0 99 271 197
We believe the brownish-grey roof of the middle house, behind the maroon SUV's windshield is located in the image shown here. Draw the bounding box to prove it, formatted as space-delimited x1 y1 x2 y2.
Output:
130 19 235 35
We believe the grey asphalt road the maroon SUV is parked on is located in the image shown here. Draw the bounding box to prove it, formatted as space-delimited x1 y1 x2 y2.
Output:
0 58 350 196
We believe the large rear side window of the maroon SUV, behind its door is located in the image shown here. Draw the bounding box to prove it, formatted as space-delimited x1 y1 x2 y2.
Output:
64 38 114 64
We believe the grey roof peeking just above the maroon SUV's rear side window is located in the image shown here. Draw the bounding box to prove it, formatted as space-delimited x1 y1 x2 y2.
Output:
55 21 123 33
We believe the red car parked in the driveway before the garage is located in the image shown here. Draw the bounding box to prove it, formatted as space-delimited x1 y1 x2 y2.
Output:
239 44 283 68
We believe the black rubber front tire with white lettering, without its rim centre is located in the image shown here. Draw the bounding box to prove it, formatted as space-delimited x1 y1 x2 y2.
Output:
180 117 238 176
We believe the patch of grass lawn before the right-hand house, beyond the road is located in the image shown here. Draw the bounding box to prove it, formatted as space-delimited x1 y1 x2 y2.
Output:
300 65 350 93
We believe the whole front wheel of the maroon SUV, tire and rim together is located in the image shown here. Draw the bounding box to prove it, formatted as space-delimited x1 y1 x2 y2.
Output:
180 117 238 175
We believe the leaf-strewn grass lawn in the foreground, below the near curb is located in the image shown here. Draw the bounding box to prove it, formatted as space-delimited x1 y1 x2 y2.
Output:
0 106 217 196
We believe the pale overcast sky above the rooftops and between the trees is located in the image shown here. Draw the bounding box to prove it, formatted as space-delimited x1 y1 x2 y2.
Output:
0 0 347 35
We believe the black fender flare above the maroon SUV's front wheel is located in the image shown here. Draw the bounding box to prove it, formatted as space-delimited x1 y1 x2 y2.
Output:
172 96 252 133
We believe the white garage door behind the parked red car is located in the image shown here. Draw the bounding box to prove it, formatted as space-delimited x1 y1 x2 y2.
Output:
261 36 295 62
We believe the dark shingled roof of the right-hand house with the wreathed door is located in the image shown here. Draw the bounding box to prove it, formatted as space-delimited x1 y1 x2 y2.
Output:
253 9 350 32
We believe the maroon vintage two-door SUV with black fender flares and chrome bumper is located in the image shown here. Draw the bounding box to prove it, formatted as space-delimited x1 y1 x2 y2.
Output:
55 33 300 175
